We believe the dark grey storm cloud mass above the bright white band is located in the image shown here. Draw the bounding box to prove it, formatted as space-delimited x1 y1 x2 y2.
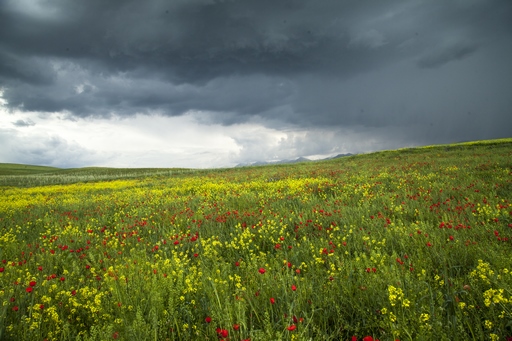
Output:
0 0 512 140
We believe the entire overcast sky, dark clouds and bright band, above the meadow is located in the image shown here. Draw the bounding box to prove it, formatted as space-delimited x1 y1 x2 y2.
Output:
0 0 512 168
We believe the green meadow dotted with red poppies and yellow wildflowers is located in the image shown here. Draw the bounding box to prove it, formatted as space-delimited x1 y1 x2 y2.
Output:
0 139 512 341
